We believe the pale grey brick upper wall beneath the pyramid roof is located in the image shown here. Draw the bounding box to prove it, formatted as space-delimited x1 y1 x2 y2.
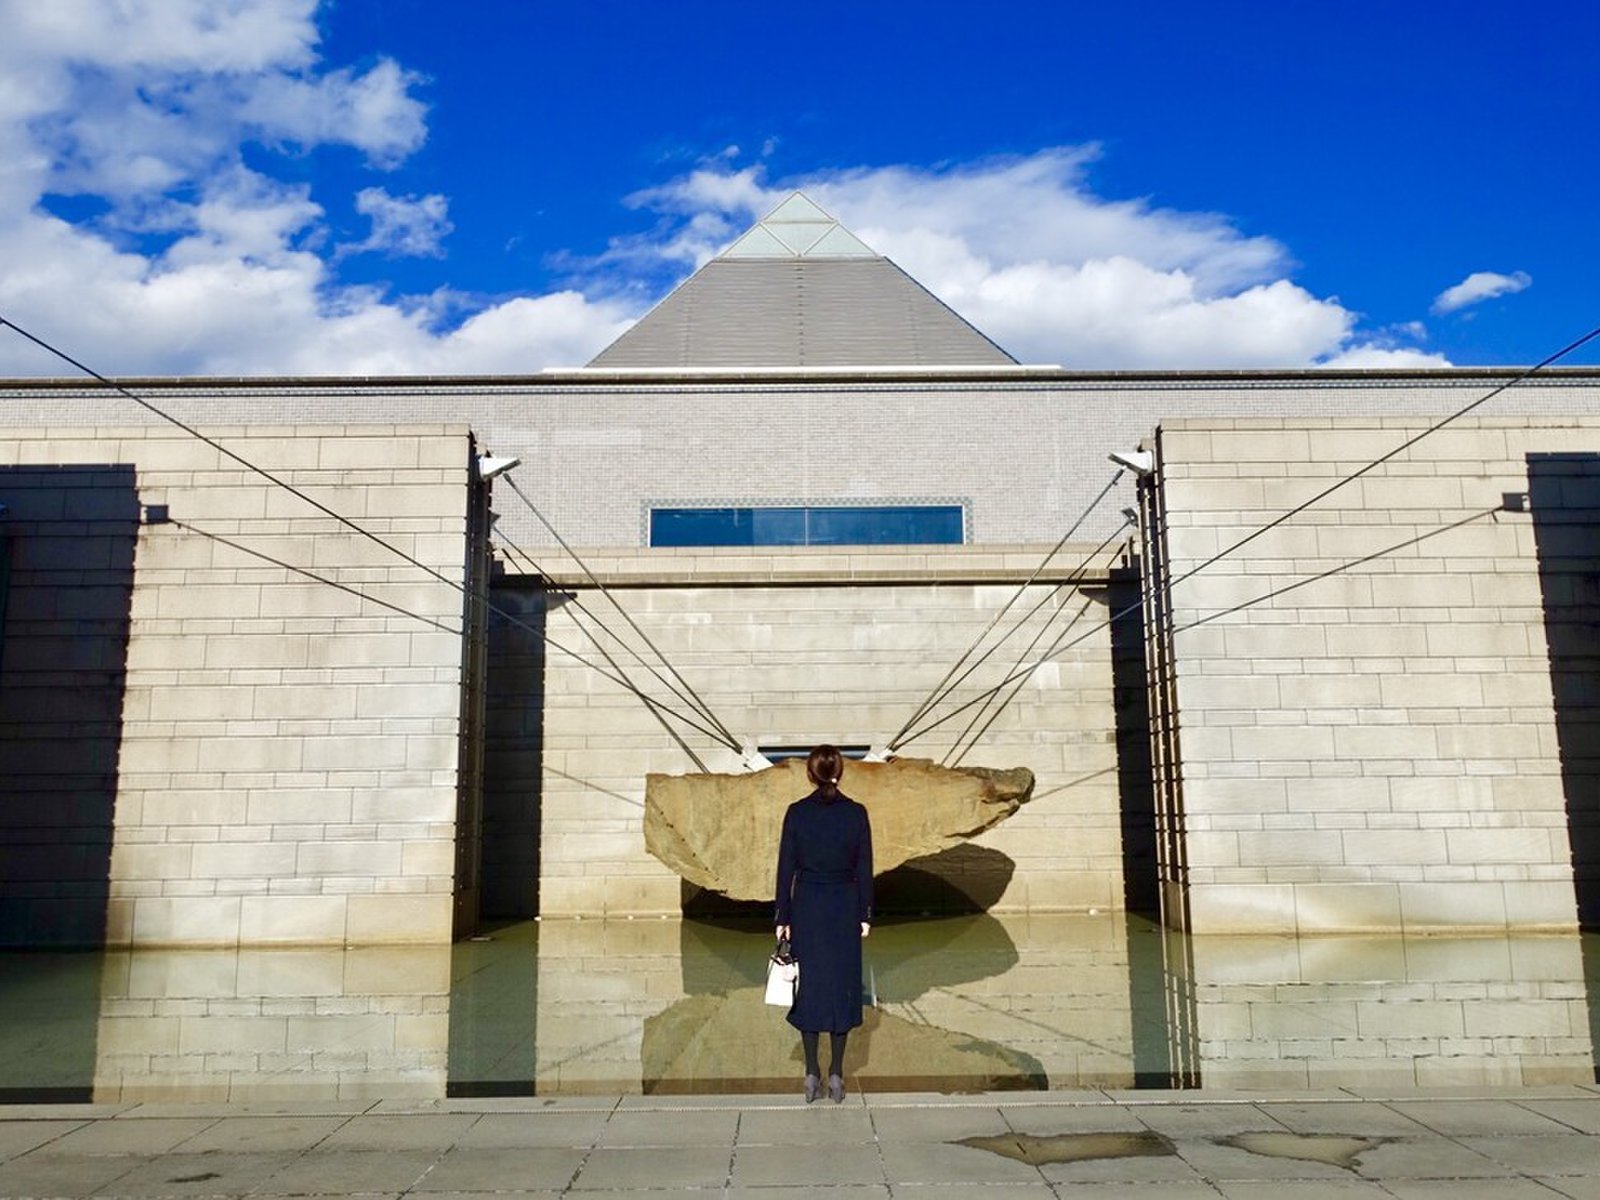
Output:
0 368 1600 550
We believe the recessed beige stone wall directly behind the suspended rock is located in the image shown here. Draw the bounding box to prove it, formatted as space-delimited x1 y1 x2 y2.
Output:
541 547 1123 915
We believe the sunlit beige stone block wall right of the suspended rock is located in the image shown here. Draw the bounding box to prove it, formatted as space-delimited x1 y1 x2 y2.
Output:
1158 418 1600 933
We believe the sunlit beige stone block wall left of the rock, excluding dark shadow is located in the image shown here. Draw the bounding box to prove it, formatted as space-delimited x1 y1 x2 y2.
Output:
0 426 470 944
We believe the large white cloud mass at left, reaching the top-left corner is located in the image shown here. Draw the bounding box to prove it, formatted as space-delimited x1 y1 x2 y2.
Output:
0 0 637 374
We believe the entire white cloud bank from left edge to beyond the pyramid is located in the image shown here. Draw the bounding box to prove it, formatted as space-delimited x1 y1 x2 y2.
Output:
0 0 1452 374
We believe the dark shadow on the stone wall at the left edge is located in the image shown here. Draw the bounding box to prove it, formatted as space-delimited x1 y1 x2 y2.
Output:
0 466 139 946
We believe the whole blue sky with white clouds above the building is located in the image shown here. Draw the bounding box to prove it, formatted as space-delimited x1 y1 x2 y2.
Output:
0 0 1600 374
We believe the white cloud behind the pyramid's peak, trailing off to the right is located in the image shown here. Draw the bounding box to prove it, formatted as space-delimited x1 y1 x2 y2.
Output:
597 155 1445 368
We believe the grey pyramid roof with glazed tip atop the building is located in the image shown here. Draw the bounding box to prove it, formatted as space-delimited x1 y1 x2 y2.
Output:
589 192 1016 370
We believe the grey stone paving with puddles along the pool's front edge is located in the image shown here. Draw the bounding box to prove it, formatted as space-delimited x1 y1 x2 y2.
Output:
0 1085 1600 1200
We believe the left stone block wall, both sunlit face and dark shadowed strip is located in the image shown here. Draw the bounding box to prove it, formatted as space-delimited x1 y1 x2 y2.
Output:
0 426 470 944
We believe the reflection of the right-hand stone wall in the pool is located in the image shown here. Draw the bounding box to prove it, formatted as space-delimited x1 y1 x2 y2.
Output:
1189 934 1595 1088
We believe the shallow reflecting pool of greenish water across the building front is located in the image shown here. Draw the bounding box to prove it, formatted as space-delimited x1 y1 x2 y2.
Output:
0 914 1600 1101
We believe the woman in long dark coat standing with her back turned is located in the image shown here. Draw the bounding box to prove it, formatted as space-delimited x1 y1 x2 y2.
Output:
778 746 872 1104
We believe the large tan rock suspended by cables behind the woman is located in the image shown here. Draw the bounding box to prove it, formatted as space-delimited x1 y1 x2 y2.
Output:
645 758 1034 901
